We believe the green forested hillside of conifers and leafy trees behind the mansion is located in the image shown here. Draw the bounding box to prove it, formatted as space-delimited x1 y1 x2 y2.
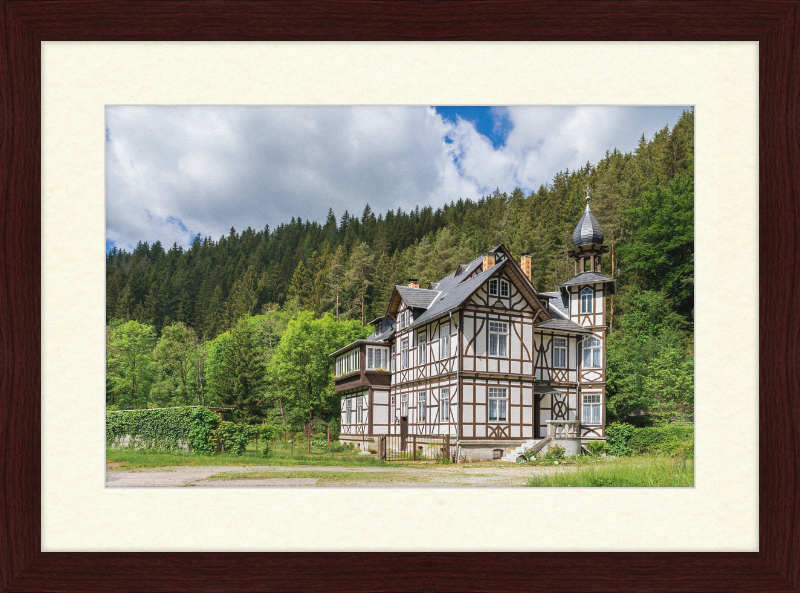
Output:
106 111 694 427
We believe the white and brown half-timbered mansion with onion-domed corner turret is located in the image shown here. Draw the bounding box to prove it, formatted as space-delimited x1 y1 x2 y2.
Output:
331 196 614 461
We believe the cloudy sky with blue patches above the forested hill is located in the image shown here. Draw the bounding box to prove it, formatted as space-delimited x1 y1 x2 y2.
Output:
106 106 688 250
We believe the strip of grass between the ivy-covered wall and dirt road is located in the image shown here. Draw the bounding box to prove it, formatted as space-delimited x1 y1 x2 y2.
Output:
106 442 387 469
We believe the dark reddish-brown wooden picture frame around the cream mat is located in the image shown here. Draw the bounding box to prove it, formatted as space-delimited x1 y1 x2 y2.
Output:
0 0 800 592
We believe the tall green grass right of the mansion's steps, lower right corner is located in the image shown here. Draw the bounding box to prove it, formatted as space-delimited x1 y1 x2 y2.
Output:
528 456 694 488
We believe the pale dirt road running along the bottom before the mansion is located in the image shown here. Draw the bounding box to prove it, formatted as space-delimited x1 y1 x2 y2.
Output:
106 462 563 488
